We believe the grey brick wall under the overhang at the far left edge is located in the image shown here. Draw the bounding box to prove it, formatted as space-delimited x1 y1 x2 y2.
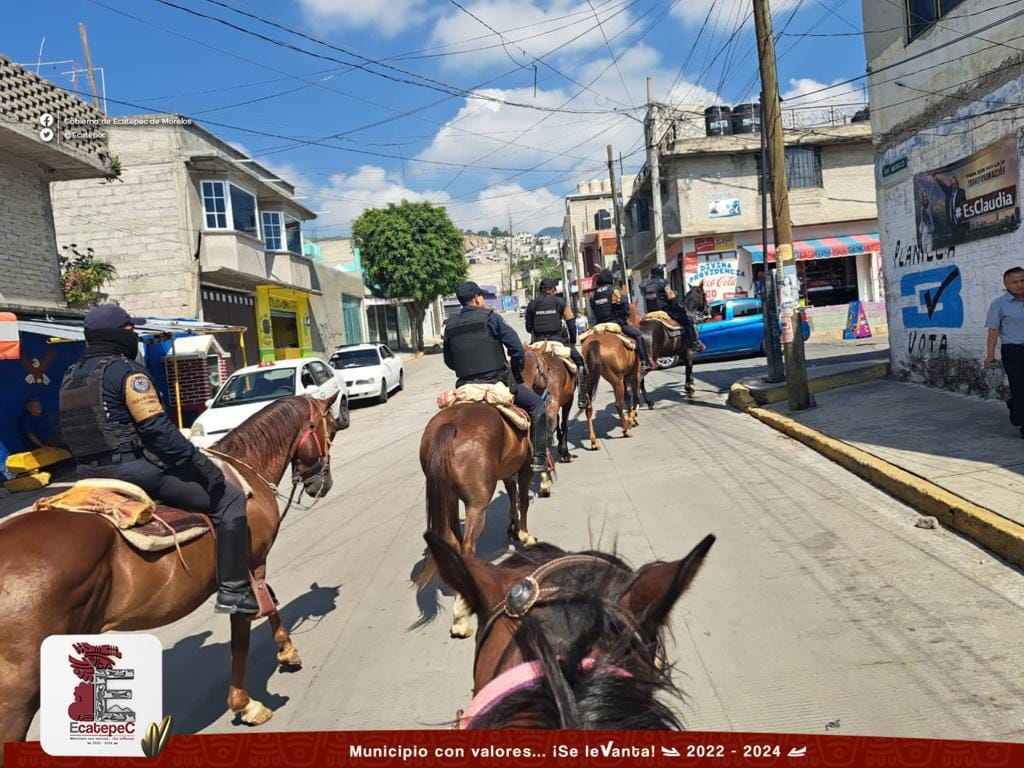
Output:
0 155 64 306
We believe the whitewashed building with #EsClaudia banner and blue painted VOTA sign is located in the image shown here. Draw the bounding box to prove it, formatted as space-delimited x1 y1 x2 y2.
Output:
862 0 1024 394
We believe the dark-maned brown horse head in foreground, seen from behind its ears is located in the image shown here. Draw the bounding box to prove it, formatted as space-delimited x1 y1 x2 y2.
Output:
425 532 715 730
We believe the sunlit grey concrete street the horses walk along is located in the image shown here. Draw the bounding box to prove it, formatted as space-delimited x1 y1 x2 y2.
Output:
30 327 1024 741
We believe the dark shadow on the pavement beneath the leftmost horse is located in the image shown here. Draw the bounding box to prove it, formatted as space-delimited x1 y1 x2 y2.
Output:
164 582 341 733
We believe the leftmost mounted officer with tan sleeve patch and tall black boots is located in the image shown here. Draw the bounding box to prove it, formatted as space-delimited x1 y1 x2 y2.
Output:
60 304 259 613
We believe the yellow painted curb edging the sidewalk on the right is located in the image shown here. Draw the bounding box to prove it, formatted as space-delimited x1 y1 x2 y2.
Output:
745 399 1024 566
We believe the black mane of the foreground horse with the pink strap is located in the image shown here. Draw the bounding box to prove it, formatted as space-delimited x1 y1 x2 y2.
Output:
470 544 683 730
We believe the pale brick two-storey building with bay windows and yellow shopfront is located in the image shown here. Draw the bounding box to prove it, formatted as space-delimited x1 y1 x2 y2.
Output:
51 115 362 367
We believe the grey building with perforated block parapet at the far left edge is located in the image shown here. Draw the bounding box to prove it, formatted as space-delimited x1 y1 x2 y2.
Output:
0 56 111 314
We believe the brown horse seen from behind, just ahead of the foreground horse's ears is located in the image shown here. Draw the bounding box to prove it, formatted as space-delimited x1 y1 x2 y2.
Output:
414 402 537 637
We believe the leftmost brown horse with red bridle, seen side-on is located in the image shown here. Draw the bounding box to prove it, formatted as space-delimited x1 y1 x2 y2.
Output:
0 395 337 741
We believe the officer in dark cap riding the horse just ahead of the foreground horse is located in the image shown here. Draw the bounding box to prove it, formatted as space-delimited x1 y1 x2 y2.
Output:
444 283 549 472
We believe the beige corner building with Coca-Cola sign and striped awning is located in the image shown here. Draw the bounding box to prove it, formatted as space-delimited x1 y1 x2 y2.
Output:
624 114 886 338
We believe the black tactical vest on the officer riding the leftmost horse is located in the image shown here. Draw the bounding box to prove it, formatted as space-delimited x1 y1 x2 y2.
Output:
60 355 141 460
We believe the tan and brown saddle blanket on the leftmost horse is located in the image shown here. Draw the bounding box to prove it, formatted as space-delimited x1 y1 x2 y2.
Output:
32 457 252 552
